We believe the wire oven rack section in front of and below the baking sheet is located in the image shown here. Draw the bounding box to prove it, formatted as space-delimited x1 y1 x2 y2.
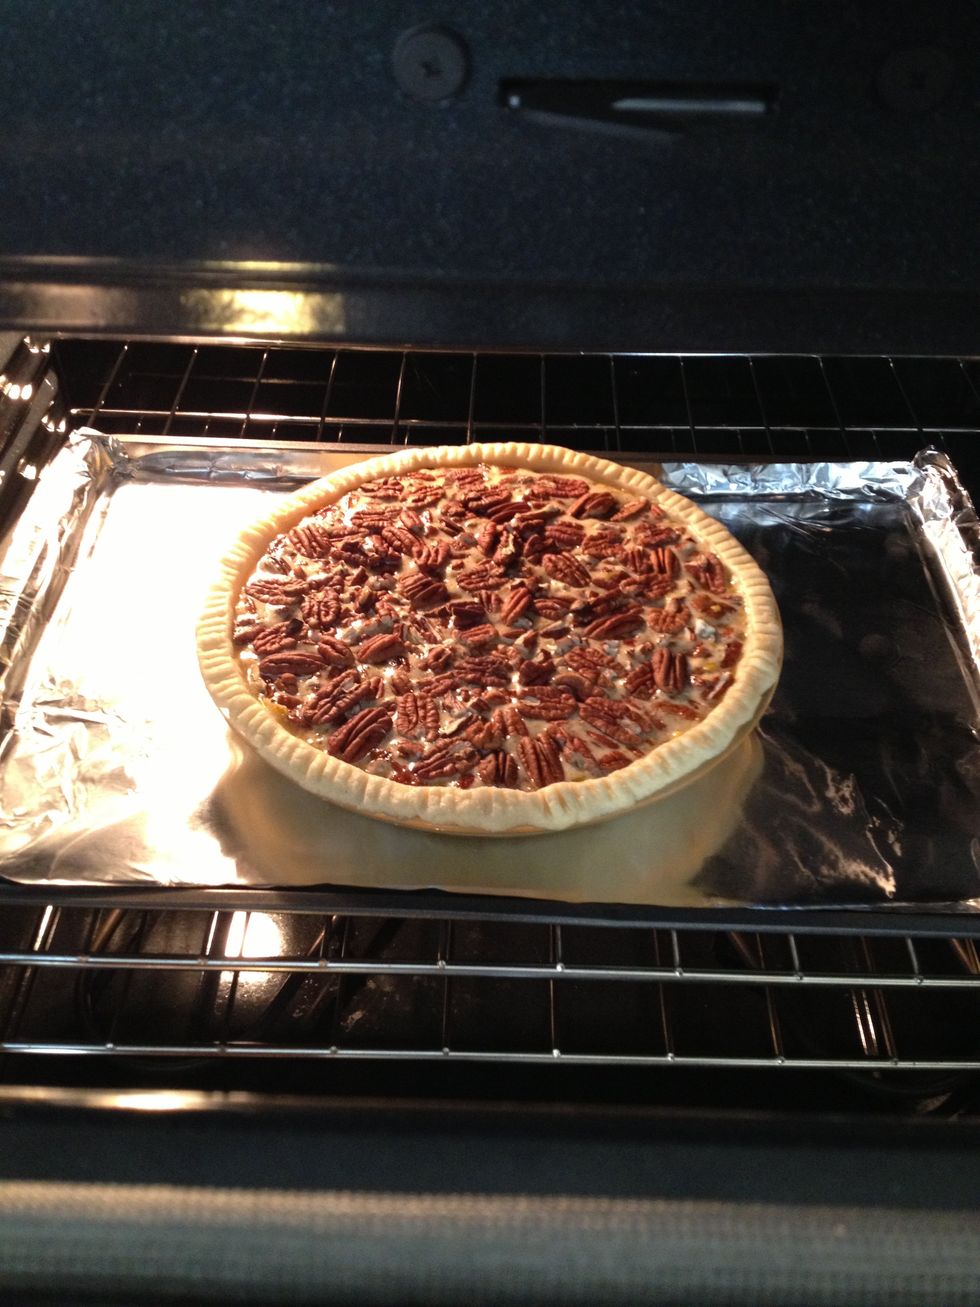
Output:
0 902 980 1078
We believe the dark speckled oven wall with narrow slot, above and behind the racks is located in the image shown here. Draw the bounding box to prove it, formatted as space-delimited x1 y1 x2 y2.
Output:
0 0 980 353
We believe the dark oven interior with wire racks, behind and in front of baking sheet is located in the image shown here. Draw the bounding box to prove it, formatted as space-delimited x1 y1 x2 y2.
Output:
0 339 980 1120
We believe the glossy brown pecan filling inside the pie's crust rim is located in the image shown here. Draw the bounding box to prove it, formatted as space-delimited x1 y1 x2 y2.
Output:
233 464 745 789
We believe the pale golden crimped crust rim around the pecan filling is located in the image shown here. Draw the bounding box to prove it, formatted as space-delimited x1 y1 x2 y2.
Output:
197 443 781 835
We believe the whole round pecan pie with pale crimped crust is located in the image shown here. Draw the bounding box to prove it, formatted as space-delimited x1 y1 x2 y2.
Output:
199 444 781 834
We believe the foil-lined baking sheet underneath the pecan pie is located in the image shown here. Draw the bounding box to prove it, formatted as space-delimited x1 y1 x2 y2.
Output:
0 433 980 911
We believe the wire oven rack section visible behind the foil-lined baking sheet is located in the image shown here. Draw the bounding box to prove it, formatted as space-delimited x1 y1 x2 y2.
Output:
54 340 980 481
